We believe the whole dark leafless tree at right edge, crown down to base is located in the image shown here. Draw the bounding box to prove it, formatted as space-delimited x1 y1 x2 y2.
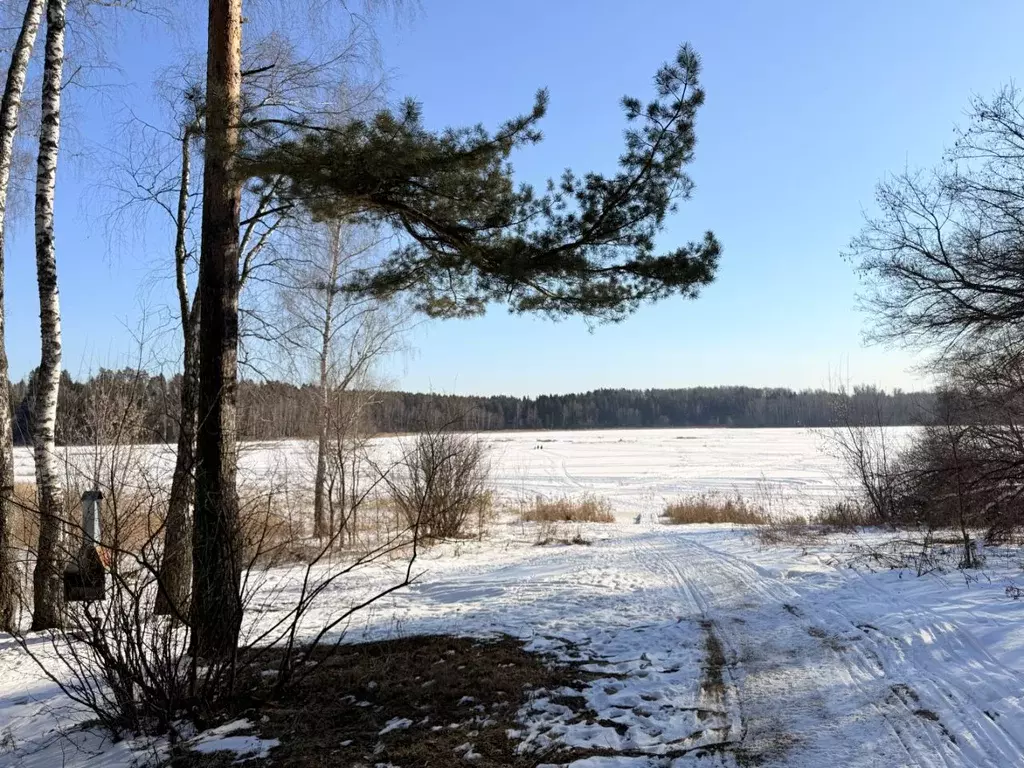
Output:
851 86 1024 548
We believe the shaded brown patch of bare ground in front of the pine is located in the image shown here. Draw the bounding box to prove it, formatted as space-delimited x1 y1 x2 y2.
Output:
171 635 595 768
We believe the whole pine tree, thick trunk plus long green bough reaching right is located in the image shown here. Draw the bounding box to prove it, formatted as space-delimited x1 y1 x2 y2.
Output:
191 27 720 654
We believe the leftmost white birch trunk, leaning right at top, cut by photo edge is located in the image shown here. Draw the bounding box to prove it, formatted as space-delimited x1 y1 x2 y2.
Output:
0 0 46 632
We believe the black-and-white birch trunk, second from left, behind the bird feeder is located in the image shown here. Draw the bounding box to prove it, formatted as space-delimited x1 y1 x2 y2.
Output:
32 0 67 630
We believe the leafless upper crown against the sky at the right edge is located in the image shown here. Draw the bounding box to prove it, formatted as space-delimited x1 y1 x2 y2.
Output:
849 87 1024 345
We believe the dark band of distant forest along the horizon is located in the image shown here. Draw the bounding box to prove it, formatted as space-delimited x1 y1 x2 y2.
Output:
11 370 934 444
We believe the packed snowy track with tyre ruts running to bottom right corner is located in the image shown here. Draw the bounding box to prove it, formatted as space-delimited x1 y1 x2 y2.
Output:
618 534 1024 768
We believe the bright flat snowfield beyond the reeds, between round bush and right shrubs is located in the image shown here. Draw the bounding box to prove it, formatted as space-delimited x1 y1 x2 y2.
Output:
482 429 872 521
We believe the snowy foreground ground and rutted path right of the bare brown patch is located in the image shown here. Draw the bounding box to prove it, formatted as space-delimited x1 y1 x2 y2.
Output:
339 525 1024 768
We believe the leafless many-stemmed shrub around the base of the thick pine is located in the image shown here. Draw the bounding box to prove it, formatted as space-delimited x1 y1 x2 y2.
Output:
16 473 418 742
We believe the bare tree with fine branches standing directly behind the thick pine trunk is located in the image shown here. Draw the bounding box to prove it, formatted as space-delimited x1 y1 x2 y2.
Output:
109 32 387 613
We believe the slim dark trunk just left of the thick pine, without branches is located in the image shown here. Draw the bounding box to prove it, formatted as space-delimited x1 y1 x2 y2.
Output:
154 126 200 618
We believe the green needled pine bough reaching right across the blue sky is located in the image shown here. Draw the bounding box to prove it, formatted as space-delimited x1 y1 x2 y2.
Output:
242 46 720 321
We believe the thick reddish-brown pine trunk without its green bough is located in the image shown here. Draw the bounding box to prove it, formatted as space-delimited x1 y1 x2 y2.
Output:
190 0 242 656
